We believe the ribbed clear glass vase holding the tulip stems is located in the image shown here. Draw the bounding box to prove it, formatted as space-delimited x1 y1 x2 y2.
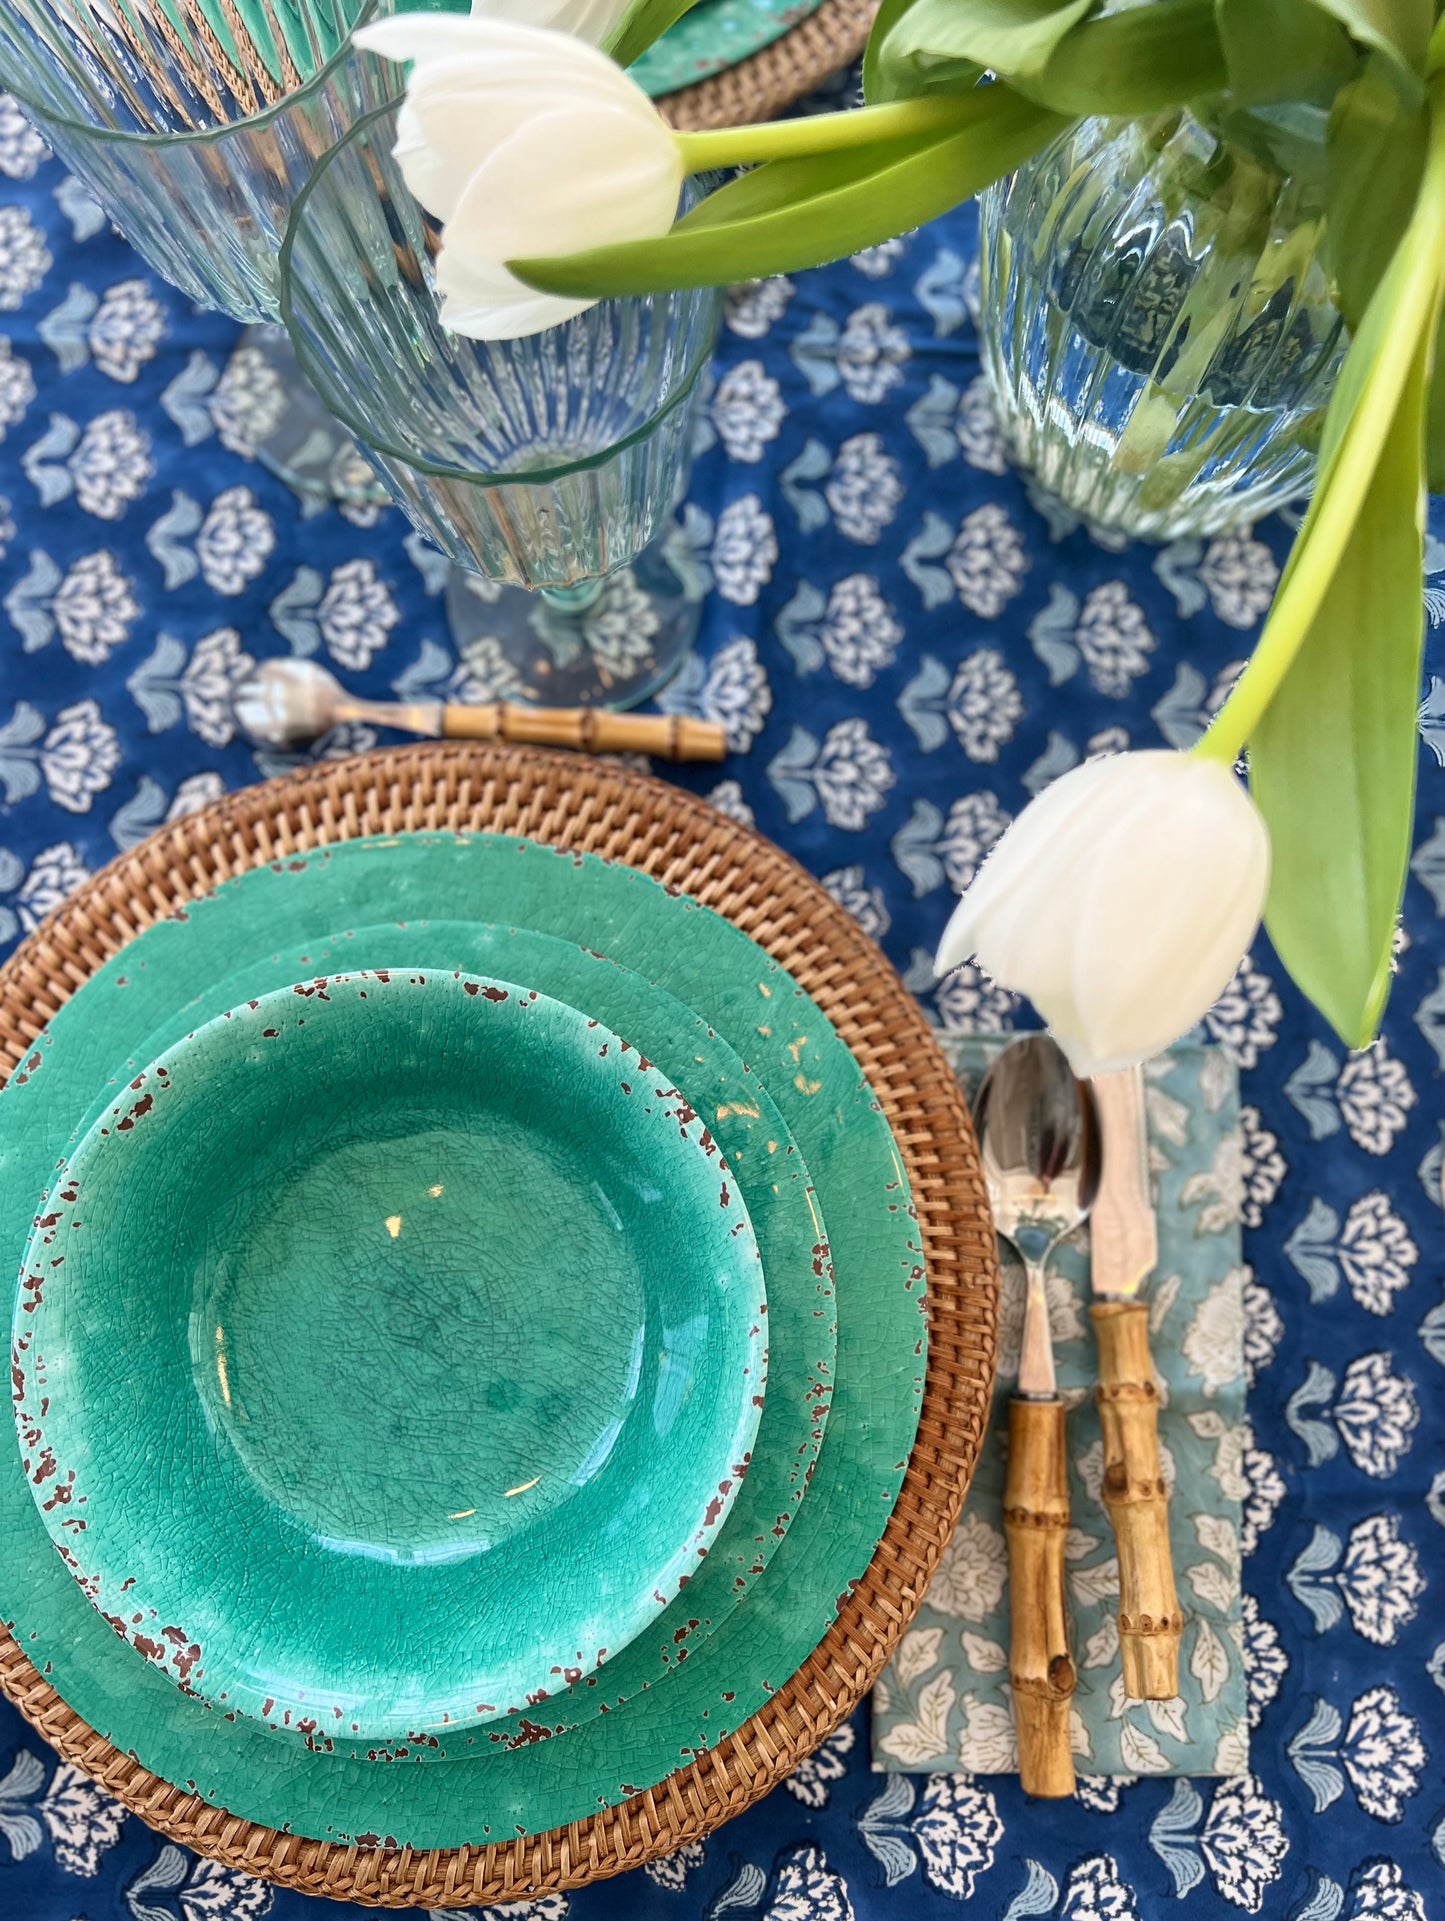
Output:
980 108 1347 540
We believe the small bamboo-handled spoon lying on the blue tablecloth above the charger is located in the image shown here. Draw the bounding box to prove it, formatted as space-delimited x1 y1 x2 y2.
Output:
234 657 728 761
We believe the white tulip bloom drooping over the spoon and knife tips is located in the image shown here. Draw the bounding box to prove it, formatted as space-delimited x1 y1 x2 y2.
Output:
934 749 1270 1076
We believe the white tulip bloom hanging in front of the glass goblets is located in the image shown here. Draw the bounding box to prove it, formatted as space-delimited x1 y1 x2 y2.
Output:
355 13 682 340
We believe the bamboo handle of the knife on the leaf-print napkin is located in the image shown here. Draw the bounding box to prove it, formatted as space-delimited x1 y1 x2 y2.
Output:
1090 1301 1184 1700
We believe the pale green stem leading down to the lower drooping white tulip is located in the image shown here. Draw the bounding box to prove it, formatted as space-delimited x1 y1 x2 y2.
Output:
1191 71 1445 766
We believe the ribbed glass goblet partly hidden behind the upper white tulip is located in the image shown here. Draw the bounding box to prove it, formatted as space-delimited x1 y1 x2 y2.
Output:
281 109 721 705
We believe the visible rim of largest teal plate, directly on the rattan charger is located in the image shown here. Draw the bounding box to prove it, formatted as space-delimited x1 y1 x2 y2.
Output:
0 834 926 1848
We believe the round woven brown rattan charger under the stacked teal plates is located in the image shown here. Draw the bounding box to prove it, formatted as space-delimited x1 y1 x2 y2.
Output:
0 745 997 1908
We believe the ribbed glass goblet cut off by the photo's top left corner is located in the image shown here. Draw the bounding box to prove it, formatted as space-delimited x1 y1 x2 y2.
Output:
0 0 398 501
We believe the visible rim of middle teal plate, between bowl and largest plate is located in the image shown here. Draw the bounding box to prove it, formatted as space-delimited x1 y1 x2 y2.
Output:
53 920 838 1762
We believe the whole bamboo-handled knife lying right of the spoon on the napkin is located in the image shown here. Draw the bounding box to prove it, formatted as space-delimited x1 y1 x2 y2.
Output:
1090 1068 1184 1700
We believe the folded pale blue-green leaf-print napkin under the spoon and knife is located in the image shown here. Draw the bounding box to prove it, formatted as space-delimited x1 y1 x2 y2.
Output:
872 1033 1249 1777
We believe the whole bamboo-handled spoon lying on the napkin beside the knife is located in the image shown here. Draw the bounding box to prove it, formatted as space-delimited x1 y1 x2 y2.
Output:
974 1033 1099 1798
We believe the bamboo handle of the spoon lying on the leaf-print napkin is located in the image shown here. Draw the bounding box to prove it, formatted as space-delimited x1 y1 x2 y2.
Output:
1003 1400 1074 1800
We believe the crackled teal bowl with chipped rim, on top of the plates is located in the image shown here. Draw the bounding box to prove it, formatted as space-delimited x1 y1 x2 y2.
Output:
13 968 767 1746
